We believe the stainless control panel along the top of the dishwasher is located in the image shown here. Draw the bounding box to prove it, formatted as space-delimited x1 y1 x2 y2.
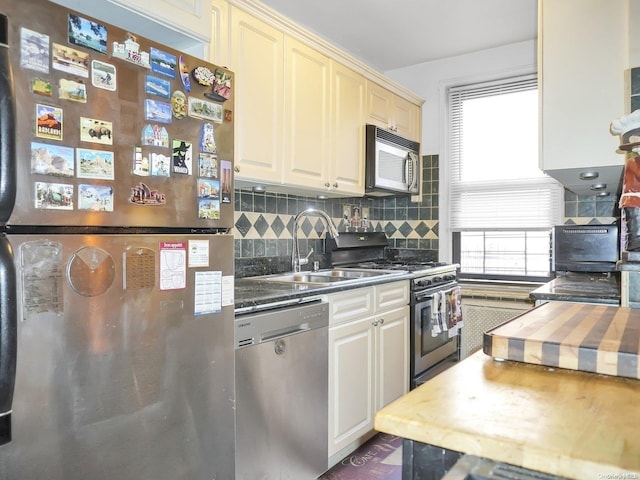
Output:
234 299 329 349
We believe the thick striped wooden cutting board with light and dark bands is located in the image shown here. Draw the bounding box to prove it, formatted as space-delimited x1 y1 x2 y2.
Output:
483 302 640 379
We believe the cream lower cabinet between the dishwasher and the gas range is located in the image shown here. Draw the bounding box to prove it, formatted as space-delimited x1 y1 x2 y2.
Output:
328 281 409 465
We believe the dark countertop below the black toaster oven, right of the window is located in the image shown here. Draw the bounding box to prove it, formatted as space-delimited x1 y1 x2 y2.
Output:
530 272 620 305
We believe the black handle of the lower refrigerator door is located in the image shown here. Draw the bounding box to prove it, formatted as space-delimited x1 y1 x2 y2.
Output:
0 234 18 445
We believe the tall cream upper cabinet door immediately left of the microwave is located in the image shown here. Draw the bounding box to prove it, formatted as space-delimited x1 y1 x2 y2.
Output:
329 62 366 196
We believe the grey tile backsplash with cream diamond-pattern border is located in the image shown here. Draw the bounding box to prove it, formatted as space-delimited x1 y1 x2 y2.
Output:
233 155 620 276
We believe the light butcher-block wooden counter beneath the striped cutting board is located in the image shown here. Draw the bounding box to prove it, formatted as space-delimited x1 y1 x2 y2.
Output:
375 352 640 480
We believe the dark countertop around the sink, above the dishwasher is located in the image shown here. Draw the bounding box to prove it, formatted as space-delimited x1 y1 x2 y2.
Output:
234 273 413 313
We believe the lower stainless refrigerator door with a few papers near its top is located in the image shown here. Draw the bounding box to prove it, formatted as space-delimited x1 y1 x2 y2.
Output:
0 235 234 480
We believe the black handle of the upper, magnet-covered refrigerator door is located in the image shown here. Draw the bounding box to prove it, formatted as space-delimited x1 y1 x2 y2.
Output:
0 14 17 225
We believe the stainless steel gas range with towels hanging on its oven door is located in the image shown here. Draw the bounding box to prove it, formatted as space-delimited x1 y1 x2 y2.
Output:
327 232 462 389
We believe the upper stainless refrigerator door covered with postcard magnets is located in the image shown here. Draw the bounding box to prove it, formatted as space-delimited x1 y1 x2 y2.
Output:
0 0 234 231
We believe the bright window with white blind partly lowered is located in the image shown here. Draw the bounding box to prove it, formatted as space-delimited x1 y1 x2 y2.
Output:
448 76 564 280
